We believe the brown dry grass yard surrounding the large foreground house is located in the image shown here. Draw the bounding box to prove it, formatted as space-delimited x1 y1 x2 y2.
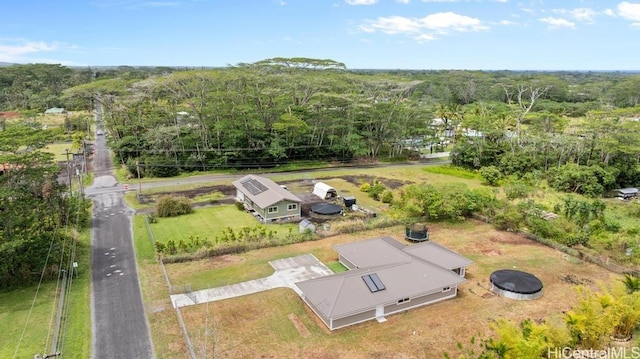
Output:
142 221 619 359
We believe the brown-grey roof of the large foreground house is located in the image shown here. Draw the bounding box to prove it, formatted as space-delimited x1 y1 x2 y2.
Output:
296 237 473 318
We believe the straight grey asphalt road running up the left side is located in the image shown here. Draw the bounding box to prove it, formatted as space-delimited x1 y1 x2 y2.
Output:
85 121 155 359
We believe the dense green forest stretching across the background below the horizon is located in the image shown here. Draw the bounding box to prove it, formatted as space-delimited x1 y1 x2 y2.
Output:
0 58 640 195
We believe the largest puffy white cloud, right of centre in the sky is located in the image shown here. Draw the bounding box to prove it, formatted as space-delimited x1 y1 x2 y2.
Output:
360 12 488 42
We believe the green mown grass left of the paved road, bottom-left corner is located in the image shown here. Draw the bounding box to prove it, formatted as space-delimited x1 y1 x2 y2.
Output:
0 231 91 359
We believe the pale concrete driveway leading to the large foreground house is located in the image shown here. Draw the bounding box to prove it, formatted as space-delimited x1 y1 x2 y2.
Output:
171 254 333 308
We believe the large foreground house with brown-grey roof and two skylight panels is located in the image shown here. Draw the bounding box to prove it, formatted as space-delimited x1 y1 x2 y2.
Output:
296 237 473 330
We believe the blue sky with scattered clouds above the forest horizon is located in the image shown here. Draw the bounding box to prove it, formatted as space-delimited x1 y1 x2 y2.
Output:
0 0 640 71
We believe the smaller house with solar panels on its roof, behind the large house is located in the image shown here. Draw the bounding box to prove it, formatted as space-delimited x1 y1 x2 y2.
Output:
233 175 302 223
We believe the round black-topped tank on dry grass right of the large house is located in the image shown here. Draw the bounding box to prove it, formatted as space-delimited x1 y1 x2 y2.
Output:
490 269 542 300
